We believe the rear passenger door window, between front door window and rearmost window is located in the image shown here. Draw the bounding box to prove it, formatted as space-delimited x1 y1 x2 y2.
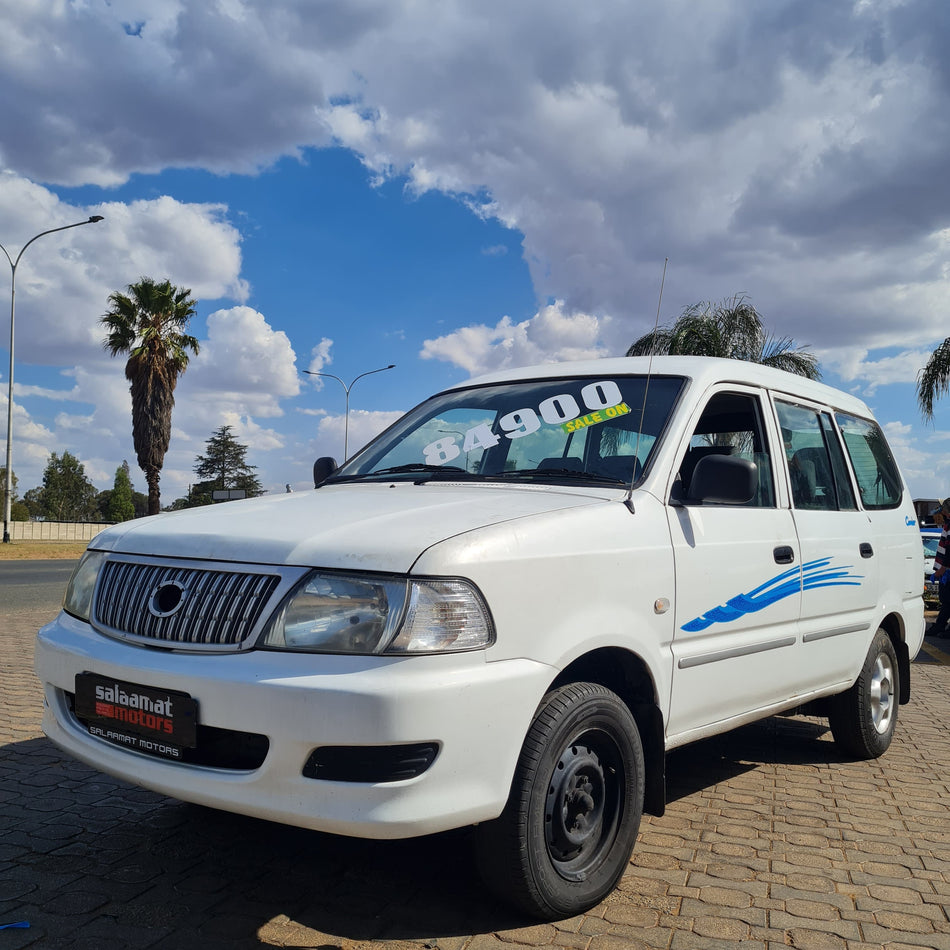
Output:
775 400 857 511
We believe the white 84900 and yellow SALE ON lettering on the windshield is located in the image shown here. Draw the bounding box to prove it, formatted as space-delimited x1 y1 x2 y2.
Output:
422 379 630 465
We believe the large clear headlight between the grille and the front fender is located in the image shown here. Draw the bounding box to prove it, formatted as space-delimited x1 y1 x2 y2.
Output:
260 571 493 655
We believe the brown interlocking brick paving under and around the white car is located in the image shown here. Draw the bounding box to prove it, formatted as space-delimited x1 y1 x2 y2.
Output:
0 609 950 950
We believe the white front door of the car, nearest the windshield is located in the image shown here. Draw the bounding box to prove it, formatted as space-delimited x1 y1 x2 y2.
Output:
667 385 802 745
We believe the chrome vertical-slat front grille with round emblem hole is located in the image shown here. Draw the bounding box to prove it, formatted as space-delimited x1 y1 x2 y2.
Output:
93 559 282 649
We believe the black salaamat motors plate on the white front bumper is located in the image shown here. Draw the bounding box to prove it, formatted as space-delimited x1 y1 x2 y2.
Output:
76 673 198 759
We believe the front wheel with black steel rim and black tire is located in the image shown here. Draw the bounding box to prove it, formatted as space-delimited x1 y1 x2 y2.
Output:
474 683 644 920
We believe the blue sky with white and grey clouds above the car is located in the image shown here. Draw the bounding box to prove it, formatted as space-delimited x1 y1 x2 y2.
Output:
0 0 950 503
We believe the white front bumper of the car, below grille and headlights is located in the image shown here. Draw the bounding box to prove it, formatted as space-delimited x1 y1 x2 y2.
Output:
35 614 556 838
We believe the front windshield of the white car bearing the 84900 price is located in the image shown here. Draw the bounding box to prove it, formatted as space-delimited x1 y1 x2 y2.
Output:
328 376 683 487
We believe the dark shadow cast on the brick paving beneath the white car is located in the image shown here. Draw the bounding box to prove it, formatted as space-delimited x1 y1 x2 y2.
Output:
0 717 840 950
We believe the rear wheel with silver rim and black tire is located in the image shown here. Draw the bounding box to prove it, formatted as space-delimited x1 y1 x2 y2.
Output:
828 630 900 759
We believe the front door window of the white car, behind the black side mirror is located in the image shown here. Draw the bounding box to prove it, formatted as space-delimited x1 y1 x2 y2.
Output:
679 393 775 508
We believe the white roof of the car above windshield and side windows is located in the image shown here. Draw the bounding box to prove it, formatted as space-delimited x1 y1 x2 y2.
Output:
458 356 871 416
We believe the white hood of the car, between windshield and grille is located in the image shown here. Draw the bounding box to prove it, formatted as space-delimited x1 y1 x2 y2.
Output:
90 482 618 572
